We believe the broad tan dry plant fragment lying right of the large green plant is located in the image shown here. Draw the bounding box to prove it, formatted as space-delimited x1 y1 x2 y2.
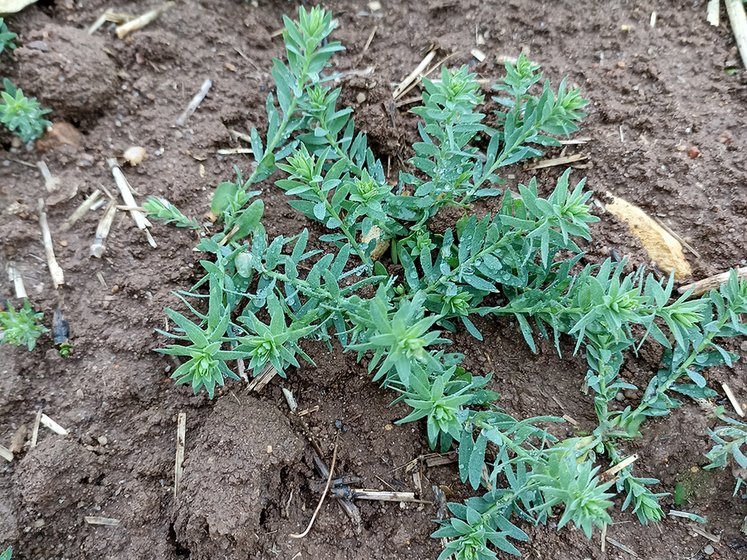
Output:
607 195 692 280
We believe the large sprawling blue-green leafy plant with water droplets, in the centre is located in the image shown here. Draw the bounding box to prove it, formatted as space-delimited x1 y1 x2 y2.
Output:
148 8 747 559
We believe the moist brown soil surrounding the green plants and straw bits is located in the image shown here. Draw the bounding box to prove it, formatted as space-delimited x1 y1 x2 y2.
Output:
0 0 747 560
